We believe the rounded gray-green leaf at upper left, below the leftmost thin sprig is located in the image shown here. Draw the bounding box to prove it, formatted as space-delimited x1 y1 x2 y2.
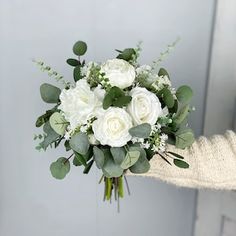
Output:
40 83 61 103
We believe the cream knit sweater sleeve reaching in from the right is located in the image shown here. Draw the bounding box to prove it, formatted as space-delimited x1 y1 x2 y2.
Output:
129 131 236 190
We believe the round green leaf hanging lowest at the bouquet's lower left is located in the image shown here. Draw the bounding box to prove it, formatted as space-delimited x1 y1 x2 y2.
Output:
50 157 70 179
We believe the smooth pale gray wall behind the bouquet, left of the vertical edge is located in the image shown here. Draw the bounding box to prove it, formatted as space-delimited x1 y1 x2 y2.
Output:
0 0 214 236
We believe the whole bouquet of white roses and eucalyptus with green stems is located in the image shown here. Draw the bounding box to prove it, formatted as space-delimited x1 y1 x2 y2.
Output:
34 41 194 208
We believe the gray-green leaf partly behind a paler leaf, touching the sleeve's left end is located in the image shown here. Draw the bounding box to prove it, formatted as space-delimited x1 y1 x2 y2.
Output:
129 147 150 174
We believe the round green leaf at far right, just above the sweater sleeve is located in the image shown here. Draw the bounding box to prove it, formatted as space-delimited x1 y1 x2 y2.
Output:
175 129 195 149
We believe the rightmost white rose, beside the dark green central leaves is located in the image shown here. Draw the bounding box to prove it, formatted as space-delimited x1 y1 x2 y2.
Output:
127 87 162 125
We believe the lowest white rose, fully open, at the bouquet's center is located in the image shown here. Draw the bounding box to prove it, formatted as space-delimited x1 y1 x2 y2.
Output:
92 107 132 147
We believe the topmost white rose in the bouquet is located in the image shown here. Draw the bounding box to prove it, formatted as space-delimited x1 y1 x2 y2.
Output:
101 59 135 89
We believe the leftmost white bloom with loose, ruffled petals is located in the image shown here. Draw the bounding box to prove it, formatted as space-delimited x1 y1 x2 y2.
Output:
59 79 102 130
